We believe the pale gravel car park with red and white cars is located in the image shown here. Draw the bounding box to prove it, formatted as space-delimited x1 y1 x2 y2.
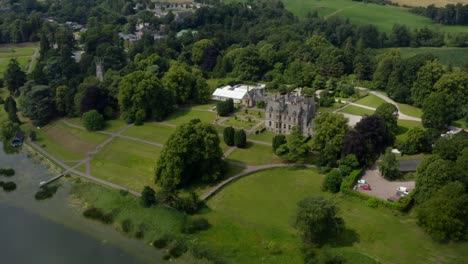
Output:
357 165 415 200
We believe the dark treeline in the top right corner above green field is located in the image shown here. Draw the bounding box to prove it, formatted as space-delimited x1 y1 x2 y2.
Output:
411 4 468 25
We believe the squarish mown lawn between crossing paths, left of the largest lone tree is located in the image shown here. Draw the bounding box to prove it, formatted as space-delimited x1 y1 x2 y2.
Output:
91 138 162 192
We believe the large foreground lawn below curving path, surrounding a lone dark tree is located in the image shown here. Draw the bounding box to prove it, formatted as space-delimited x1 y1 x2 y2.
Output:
194 168 468 264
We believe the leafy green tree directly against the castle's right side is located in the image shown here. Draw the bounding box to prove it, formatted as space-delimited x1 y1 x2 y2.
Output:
312 113 348 151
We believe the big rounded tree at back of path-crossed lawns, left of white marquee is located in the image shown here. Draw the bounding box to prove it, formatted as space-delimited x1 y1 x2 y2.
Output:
118 71 174 123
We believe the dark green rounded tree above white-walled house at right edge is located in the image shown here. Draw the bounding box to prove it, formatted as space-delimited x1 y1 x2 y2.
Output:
421 92 455 130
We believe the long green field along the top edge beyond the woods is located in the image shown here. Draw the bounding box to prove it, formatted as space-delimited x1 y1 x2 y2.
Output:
276 0 468 32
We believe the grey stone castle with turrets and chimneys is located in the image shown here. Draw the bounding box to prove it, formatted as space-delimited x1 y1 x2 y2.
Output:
265 94 316 136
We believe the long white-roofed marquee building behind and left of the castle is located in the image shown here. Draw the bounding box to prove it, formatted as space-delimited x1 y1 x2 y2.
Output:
211 84 265 107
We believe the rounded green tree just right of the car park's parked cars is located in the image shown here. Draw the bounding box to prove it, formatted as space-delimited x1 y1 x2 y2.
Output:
414 155 456 204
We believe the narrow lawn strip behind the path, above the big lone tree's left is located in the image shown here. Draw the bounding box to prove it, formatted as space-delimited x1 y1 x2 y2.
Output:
124 123 175 144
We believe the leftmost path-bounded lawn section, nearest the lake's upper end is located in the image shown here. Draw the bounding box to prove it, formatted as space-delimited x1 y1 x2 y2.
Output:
36 121 108 160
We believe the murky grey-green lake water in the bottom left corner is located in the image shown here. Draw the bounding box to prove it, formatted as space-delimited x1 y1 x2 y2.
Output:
0 144 162 264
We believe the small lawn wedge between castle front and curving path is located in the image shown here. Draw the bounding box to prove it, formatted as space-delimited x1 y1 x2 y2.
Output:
227 142 281 165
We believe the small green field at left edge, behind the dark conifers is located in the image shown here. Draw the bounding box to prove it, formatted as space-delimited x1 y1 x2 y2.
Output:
0 43 38 76
